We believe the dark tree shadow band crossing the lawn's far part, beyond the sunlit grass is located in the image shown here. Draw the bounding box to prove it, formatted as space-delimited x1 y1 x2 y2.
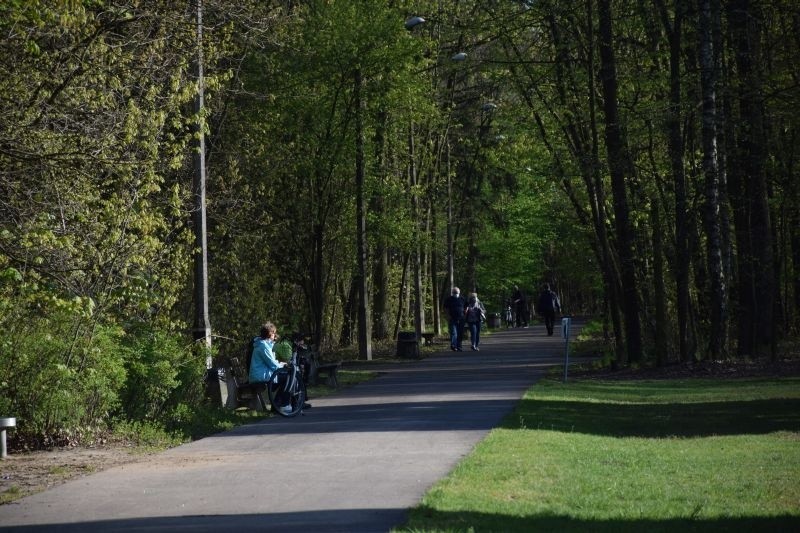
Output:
503 398 800 438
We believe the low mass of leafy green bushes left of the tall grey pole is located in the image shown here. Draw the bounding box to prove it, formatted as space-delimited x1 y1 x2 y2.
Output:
0 269 205 446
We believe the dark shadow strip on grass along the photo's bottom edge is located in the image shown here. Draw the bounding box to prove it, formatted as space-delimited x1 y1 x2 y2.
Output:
395 507 800 533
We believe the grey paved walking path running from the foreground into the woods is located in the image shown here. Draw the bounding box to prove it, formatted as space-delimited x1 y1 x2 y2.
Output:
0 318 588 533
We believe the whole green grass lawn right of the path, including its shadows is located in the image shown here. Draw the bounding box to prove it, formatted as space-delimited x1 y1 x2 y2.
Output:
399 378 800 532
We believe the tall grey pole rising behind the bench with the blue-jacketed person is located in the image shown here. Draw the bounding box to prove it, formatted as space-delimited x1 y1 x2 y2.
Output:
192 0 211 362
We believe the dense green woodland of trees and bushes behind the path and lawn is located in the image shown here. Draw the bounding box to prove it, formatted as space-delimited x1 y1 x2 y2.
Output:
0 0 800 441
